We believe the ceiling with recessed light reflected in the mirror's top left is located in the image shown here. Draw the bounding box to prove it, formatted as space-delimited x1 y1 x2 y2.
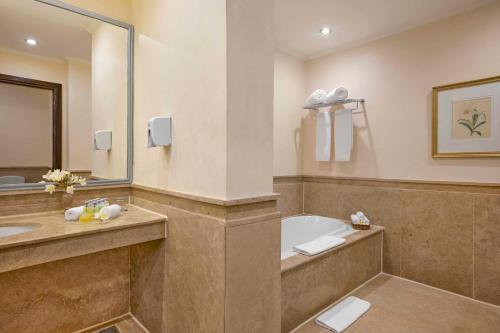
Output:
0 0 95 61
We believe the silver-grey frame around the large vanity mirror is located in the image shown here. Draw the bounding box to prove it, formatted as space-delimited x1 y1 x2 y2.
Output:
0 0 134 191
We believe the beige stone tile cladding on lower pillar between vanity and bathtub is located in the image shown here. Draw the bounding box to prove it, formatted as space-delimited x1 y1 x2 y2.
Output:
131 188 281 333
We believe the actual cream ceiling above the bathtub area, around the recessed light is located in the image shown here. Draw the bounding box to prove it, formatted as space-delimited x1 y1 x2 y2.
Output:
274 0 495 59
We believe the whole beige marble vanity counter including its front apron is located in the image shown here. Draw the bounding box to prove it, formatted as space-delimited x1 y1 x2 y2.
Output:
0 205 166 273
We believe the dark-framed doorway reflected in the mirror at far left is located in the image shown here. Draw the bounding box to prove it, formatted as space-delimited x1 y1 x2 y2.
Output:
0 74 62 184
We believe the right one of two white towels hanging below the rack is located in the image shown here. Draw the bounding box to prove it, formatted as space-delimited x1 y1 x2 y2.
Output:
333 109 353 162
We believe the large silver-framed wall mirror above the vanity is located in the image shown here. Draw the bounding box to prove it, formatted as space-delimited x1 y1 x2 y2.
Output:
0 0 133 190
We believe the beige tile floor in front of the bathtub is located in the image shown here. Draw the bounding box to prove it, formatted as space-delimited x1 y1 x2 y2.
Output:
293 274 500 333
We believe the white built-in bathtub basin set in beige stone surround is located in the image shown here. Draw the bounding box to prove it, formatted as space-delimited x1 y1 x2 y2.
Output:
281 215 356 260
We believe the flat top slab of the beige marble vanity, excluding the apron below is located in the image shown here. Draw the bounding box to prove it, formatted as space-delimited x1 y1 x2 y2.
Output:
0 205 166 250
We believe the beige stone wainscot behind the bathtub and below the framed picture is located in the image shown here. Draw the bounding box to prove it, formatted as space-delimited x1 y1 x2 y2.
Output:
280 177 500 305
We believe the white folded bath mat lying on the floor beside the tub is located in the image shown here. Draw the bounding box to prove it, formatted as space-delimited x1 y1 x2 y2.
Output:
316 296 370 333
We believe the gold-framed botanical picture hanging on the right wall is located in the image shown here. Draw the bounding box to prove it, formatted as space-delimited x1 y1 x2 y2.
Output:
432 76 500 158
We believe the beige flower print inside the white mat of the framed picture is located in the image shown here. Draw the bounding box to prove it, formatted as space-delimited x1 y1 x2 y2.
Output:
452 97 491 139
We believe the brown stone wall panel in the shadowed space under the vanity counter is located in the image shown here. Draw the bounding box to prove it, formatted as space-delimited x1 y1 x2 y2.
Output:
0 247 130 333
